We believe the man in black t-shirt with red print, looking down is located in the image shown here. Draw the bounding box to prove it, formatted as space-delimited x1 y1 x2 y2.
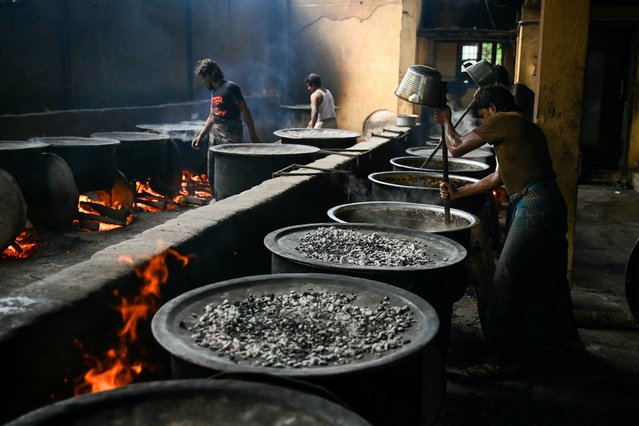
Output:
191 59 260 148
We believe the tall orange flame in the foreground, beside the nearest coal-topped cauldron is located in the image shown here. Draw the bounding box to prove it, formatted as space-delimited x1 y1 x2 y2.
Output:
75 249 190 396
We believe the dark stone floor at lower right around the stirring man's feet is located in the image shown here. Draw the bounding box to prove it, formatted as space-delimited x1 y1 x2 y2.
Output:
440 184 639 426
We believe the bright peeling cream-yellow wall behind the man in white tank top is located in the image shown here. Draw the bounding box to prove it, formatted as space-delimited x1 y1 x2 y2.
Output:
286 0 404 131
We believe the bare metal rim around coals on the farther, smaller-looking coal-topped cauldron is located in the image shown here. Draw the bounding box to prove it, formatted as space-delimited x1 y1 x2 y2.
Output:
264 222 467 274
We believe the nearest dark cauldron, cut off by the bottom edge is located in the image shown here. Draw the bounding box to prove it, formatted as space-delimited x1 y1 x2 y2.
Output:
7 379 370 426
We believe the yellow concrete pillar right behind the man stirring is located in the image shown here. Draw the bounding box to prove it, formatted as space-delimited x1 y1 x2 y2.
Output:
535 0 590 277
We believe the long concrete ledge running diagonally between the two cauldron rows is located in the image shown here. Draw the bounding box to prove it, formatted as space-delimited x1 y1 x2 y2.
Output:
0 128 420 421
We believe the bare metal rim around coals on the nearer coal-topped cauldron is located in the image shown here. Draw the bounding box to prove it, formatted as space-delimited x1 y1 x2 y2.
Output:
151 273 439 377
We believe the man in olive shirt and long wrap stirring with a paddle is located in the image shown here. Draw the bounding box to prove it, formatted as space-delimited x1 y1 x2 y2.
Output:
435 85 583 377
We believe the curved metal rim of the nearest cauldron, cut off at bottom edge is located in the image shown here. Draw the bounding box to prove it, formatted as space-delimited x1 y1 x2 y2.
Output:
7 379 370 426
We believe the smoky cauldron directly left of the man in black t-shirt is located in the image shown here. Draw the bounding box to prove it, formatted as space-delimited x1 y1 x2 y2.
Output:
136 123 209 174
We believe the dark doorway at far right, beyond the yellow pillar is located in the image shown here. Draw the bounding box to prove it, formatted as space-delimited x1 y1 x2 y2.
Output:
580 24 633 178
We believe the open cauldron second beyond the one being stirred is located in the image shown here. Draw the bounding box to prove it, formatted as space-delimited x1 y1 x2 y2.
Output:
390 155 489 179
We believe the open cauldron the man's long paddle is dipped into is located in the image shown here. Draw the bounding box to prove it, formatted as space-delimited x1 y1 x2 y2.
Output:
327 201 480 251
